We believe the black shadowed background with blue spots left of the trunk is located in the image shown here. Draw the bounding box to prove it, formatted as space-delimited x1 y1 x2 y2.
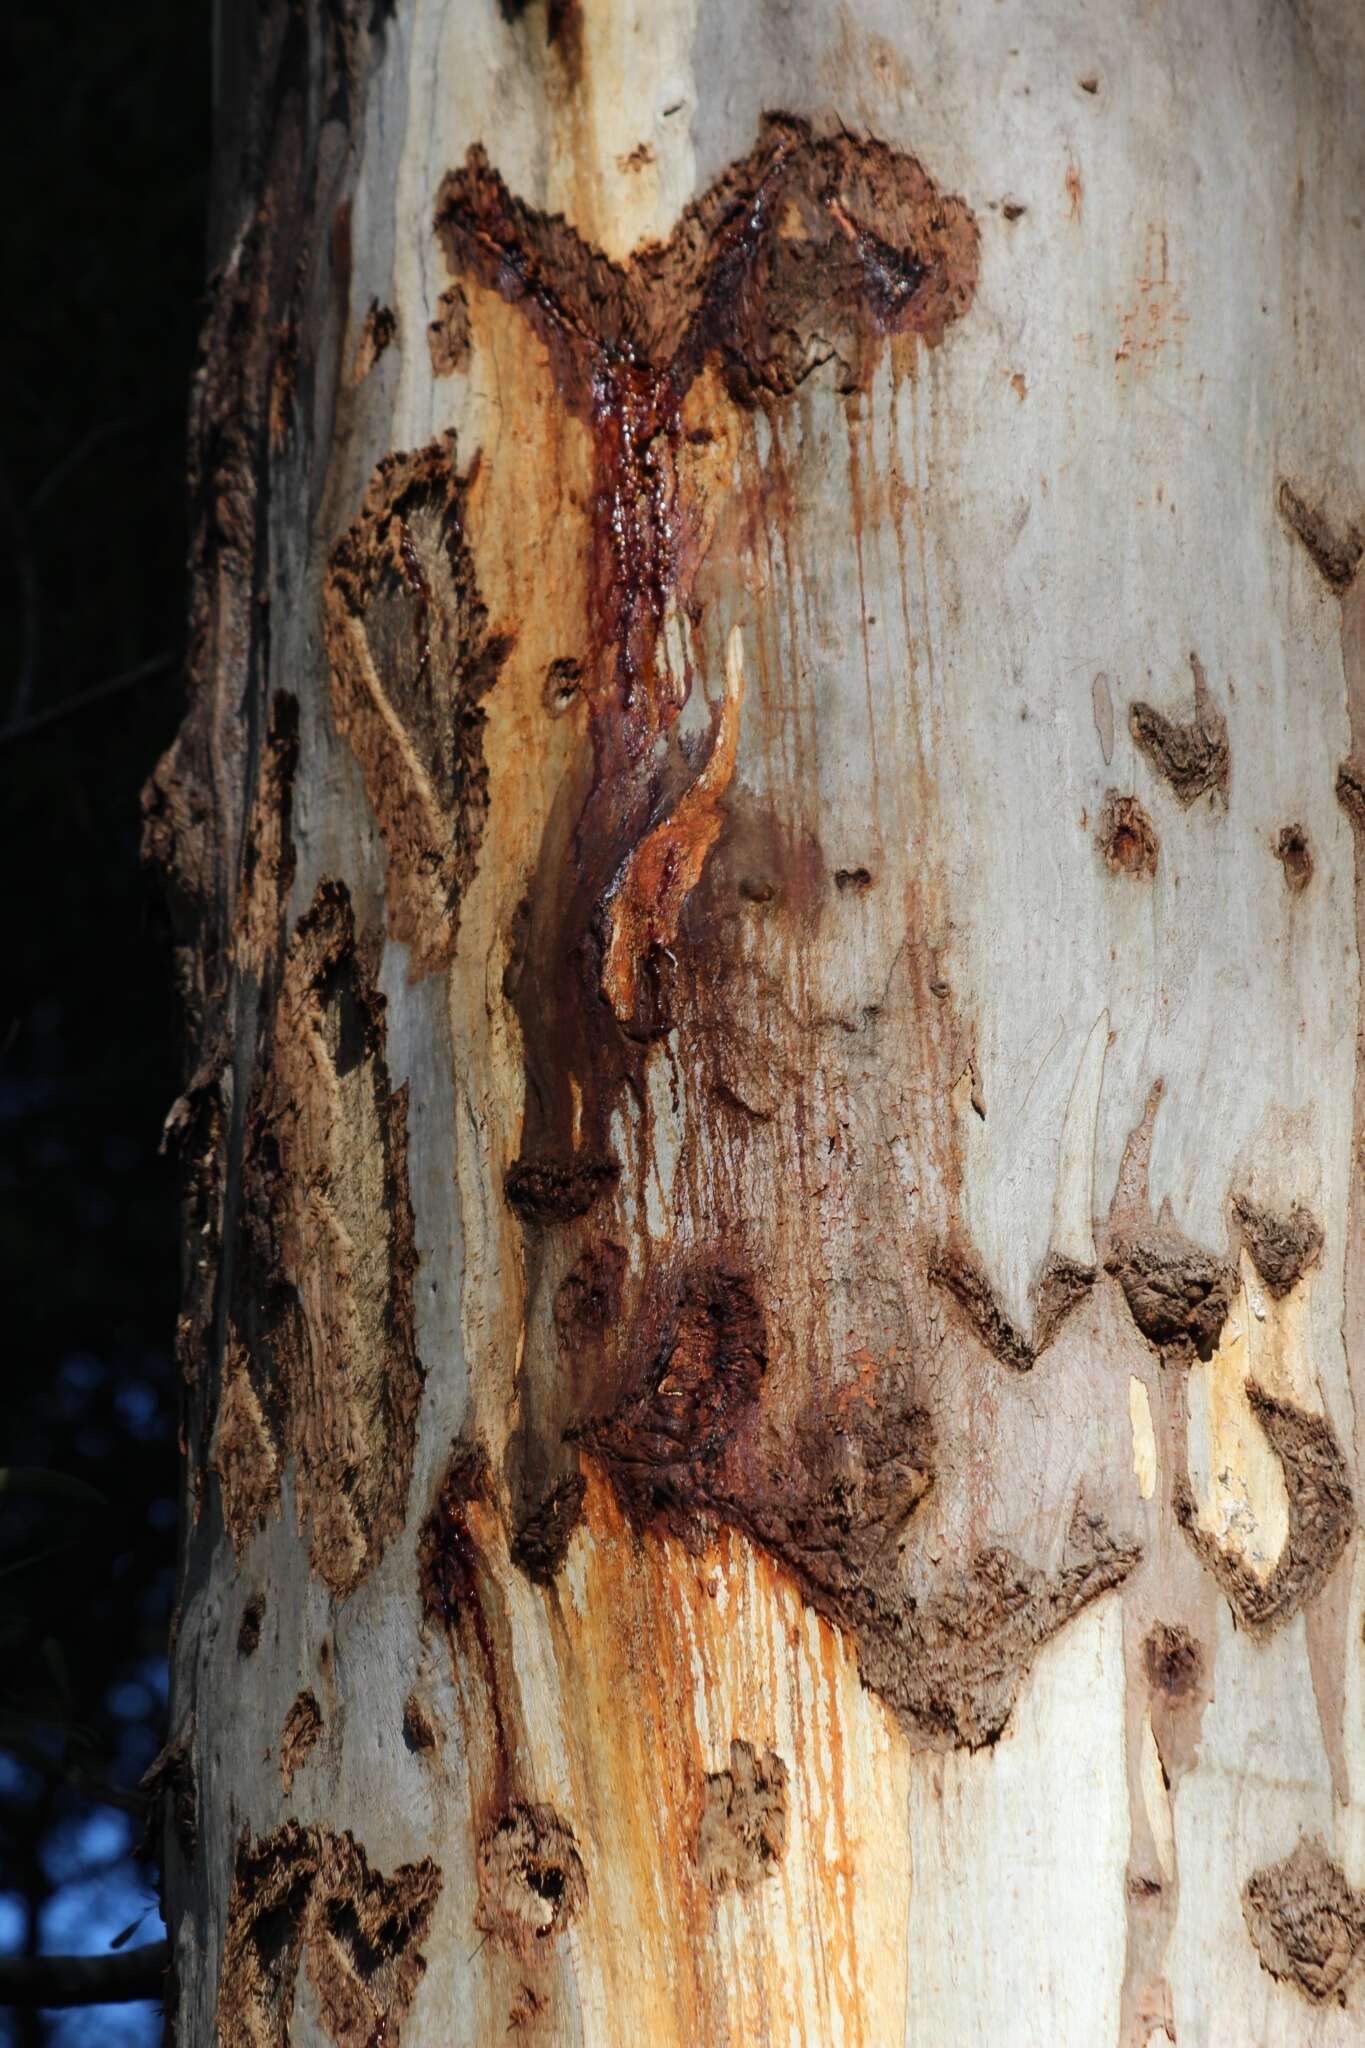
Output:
0 0 211 2048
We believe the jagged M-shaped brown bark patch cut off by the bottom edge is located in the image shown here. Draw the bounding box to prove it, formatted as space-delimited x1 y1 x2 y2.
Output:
217 1821 442 2048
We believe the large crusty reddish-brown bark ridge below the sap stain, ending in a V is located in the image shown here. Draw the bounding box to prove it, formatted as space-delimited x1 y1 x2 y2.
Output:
571 1268 1140 1749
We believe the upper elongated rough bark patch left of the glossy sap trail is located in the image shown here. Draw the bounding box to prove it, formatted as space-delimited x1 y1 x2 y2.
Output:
323 436 508 977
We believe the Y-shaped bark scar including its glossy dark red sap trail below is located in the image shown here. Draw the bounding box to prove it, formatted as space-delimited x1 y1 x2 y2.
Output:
436 117 978 1225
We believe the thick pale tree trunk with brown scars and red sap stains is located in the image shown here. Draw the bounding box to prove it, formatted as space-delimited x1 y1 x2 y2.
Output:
147 0 1365 2048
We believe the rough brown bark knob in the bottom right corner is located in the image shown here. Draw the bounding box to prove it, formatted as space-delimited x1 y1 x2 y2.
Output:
1242 1835 1365 2005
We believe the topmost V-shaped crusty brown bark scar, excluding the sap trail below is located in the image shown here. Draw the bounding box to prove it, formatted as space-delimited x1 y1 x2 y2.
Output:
436 115 978 399
